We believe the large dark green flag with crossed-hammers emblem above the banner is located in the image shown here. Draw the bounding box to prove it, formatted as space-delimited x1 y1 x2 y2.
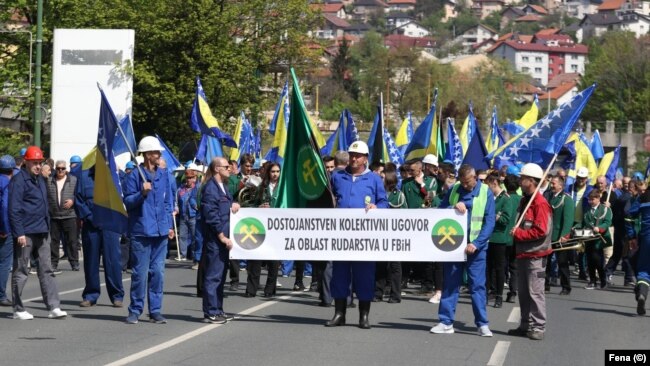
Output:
275 68 334 208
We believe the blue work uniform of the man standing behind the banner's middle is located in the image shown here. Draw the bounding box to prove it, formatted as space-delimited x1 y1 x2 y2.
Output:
331 169 388 301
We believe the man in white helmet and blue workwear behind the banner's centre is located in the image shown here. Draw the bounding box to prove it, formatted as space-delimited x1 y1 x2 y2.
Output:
325 141 384 329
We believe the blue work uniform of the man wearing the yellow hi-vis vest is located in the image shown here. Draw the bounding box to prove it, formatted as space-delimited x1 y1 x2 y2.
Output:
438 182 496 327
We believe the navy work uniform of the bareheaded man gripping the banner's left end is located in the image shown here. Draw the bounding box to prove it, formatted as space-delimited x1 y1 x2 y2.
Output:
200 179 232 317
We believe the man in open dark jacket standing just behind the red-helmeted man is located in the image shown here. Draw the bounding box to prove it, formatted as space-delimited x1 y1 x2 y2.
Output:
47 160 79 274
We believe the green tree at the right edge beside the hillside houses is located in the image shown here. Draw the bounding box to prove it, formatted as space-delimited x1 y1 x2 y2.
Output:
581 32 650 123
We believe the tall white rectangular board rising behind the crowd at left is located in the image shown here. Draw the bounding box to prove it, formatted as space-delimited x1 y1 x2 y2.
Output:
50 29 135 165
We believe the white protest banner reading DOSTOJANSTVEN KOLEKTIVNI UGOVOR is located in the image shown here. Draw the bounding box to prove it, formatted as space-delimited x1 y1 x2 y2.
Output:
230 208 467 262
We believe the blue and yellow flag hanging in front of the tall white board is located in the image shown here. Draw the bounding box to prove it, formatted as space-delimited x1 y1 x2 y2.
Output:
93 88 127 233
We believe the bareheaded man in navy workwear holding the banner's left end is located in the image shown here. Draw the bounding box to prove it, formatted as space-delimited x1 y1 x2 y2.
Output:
200 158 238 324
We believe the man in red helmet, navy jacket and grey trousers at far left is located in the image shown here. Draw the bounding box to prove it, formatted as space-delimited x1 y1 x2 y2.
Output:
9 146 68 320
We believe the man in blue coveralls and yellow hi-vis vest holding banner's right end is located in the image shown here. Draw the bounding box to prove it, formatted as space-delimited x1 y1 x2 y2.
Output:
431 164 496 337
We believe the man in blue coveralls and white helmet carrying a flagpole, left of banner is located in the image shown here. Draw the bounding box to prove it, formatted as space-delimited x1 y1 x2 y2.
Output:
124 136 174 324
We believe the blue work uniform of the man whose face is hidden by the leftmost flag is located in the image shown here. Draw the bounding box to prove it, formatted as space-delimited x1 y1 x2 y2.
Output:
74 167 124 304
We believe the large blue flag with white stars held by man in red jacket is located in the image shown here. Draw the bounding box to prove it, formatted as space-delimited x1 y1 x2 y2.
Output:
488 84 596 167
